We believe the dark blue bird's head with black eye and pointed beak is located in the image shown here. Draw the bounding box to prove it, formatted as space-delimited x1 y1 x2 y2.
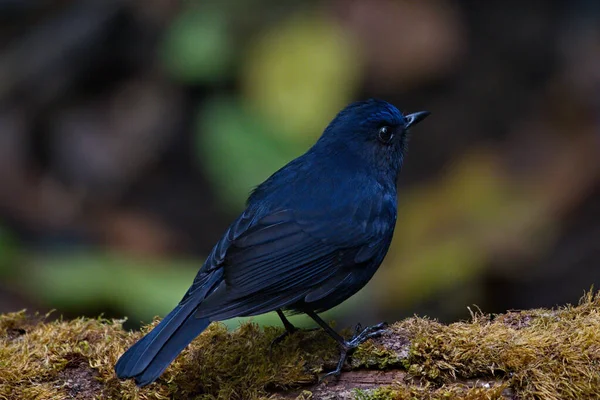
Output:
316 99 429 178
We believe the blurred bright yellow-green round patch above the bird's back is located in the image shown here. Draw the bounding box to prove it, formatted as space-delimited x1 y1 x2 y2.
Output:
242 14 362 148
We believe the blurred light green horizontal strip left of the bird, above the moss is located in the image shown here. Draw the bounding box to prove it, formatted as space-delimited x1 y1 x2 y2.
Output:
27 251 198 322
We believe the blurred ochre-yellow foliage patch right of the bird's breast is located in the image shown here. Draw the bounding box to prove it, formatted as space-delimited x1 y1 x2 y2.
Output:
378 152 520 302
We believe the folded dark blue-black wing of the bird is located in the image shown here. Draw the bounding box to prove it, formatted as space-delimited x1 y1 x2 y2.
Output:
192 195 393 320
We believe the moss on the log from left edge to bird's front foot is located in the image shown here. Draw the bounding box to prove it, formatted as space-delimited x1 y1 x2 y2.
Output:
0 312 337 399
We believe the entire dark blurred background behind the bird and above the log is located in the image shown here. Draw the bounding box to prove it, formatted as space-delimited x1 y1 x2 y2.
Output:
0 0 600 328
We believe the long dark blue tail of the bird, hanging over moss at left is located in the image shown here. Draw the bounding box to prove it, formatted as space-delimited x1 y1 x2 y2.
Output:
115 302 210 386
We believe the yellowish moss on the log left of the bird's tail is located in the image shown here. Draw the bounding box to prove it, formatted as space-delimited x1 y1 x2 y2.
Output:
0 312 127 399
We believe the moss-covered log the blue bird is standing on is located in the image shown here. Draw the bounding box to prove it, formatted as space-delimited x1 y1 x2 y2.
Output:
0 293 600 399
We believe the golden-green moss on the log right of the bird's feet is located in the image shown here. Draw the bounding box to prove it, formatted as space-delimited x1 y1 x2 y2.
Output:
400 293 600 400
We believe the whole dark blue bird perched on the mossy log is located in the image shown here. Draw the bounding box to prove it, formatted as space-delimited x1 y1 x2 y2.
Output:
115 98 430 387
